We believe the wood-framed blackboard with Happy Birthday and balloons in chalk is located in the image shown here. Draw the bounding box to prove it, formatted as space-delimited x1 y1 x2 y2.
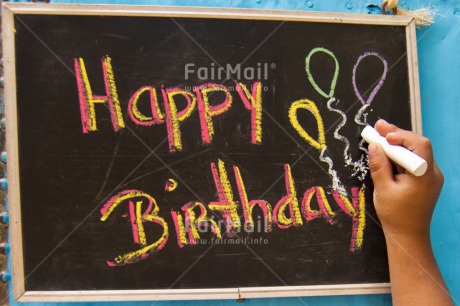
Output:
3 4 421 301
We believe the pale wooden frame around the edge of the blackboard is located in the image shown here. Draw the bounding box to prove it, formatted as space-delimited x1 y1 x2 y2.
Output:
2 3 422 302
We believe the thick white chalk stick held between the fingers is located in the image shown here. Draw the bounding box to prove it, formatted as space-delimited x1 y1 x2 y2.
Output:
361 125 428 176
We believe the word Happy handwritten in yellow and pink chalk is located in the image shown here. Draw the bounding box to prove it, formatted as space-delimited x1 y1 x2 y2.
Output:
74 56 262 152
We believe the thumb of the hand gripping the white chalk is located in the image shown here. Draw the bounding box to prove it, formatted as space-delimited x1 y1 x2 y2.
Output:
369 143 393 188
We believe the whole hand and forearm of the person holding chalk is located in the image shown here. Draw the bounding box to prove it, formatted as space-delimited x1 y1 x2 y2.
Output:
369 120 454 306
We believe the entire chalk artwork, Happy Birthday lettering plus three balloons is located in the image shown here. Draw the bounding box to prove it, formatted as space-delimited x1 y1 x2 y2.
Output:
74 48 388 266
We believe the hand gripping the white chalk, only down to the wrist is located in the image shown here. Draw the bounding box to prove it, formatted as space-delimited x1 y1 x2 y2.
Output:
369 120 444 236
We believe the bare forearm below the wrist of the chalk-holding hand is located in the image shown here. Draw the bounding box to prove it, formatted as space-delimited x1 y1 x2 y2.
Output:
385 233 453 306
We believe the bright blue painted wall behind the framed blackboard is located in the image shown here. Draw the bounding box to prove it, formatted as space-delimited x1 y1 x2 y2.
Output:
7 0 460 306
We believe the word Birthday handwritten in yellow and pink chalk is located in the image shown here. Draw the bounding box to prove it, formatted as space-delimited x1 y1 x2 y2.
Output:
100 160 366 266
